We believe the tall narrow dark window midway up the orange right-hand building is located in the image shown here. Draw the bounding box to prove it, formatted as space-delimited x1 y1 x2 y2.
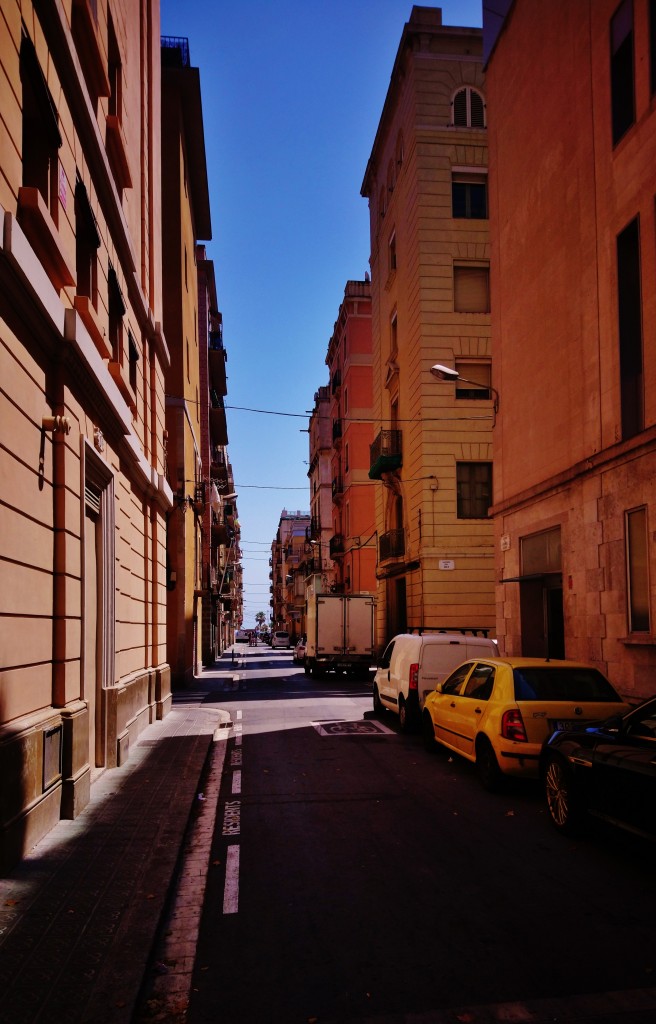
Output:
617 218 645 439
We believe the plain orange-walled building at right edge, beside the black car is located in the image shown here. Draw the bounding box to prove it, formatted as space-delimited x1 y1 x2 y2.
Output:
484 0 656 696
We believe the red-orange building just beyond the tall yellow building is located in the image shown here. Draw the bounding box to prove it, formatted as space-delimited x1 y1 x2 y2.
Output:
325 280 377 594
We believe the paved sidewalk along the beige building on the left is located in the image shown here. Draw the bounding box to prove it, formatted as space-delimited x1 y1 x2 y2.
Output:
0 679 230 1024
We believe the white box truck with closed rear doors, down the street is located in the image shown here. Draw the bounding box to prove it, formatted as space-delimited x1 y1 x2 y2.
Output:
304 587 376 679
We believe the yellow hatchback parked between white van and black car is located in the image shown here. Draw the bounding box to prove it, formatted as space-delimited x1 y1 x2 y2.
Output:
422 657 628 790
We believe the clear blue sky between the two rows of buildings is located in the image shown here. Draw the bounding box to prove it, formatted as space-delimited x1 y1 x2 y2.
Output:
162 0 482 627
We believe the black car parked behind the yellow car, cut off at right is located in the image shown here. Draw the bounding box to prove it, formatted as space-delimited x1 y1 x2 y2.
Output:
541 696 656 839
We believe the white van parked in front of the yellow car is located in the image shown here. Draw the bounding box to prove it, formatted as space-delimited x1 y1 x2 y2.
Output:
374 633 498 731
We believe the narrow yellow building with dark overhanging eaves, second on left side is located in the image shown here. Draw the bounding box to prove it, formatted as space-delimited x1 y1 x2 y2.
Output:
162 37 213 688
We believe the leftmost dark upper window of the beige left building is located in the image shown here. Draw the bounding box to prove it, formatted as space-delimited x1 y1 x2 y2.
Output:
20 32 61 219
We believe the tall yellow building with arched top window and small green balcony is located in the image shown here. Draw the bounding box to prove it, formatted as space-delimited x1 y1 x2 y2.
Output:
361 6 496 646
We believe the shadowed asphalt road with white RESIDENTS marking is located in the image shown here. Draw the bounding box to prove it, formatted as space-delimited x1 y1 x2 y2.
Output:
180 648 656 1024
